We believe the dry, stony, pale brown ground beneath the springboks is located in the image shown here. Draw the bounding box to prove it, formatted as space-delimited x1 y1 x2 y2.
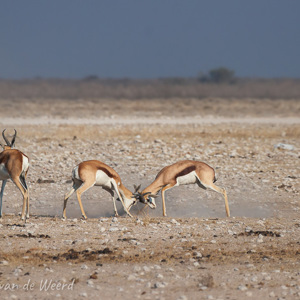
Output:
0 99 300 299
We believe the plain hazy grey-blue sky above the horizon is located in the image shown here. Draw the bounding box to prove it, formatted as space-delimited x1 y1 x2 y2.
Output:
0 0 300 78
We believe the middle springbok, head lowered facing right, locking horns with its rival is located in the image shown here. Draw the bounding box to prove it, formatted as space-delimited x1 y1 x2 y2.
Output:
63 160 137 219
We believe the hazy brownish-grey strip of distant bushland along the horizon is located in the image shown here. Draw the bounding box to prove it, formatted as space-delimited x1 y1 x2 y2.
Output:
0 76 300 100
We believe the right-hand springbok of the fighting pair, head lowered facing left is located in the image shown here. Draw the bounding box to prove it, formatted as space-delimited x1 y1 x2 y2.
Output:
135 160 230 217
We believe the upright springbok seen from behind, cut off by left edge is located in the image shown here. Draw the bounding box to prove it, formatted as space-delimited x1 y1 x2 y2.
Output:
0 129 29 220
